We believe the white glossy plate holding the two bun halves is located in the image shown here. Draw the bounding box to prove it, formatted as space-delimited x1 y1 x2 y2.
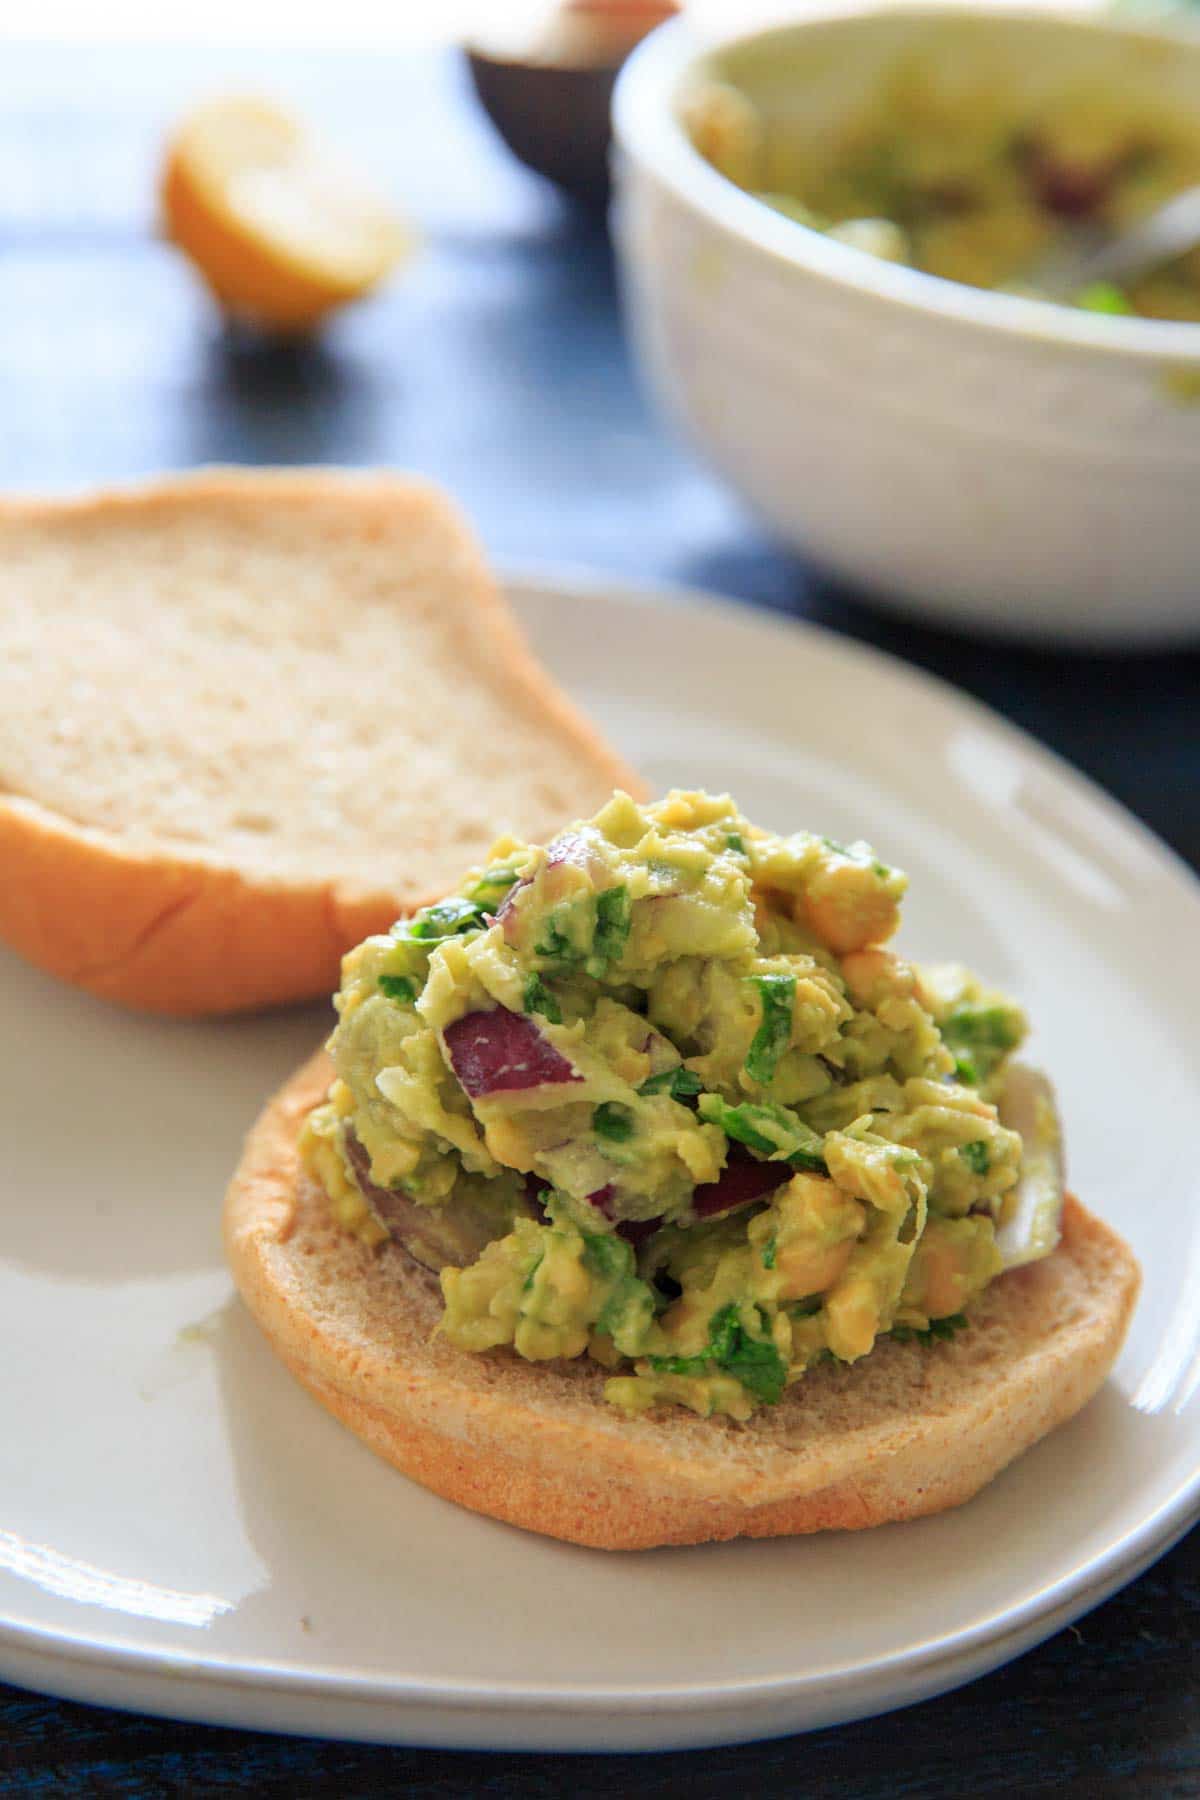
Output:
0 578 1200 1750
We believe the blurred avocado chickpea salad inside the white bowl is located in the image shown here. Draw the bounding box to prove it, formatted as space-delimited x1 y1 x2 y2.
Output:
684 54 1200 320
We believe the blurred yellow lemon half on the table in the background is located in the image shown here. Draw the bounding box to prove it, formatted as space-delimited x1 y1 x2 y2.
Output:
162 97 408 331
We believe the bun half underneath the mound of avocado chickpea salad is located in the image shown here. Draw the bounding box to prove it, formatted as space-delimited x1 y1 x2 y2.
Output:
225 1055 1139 1550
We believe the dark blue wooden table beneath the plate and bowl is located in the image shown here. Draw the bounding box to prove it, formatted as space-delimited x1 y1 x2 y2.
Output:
0 31 1200 1800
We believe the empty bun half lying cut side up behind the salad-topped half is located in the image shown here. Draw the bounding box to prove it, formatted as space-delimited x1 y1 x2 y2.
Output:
0 470 640 1013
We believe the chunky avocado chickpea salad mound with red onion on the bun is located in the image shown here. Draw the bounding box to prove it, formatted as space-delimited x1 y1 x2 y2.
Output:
302 792 1061 1420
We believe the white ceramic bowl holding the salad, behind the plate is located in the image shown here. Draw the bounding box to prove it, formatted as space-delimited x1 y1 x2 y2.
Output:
613 5 1200 644
